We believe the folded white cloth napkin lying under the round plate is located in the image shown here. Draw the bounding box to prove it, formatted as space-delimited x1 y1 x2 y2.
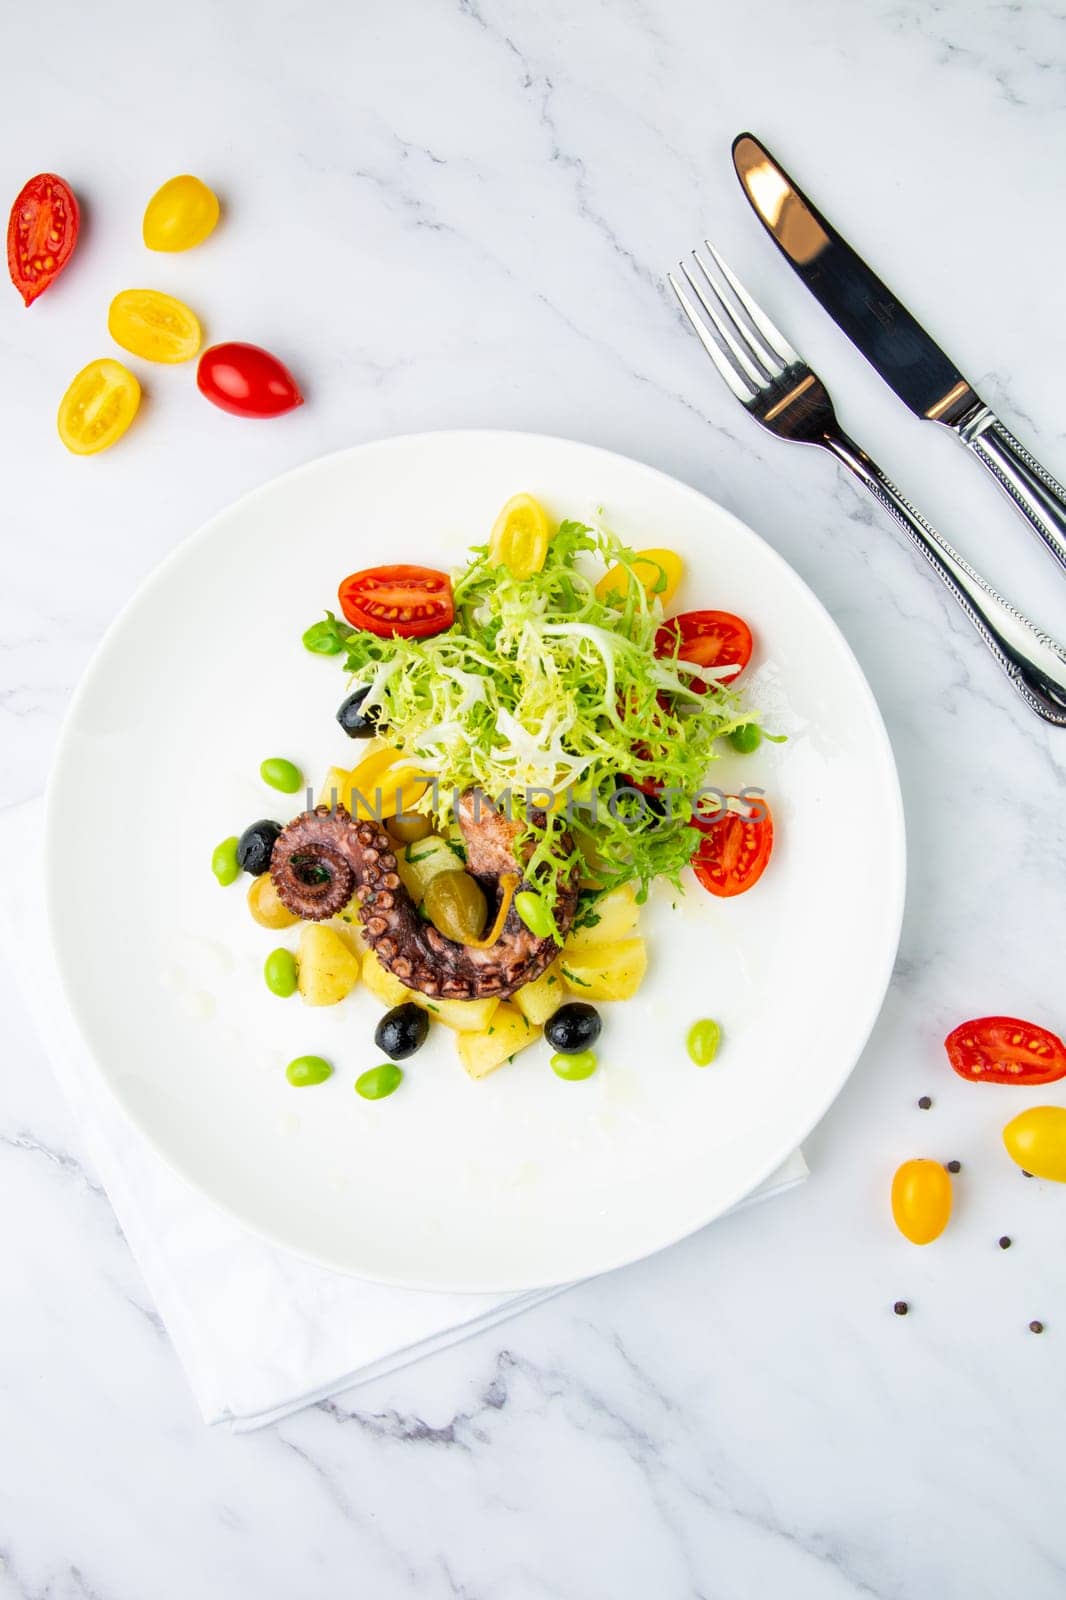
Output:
0 800 807 1432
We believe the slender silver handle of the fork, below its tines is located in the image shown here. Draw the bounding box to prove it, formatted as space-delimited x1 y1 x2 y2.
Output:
823 432 1066 728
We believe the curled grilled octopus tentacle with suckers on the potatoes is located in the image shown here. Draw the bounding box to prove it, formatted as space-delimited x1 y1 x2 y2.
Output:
271 790 578 1000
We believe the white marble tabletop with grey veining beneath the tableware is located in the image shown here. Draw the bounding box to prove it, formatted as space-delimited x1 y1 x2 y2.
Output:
0 0 1066 1600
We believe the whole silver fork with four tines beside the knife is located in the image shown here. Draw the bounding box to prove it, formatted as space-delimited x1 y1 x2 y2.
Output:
667 240 1066 728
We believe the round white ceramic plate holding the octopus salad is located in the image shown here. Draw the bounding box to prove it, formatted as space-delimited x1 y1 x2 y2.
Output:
48 432 904 1290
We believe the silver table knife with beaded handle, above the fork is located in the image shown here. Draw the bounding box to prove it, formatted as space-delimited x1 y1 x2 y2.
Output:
733 133 1066 568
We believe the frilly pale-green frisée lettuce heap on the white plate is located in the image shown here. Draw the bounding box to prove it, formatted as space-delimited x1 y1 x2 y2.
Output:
304 522 755 934
